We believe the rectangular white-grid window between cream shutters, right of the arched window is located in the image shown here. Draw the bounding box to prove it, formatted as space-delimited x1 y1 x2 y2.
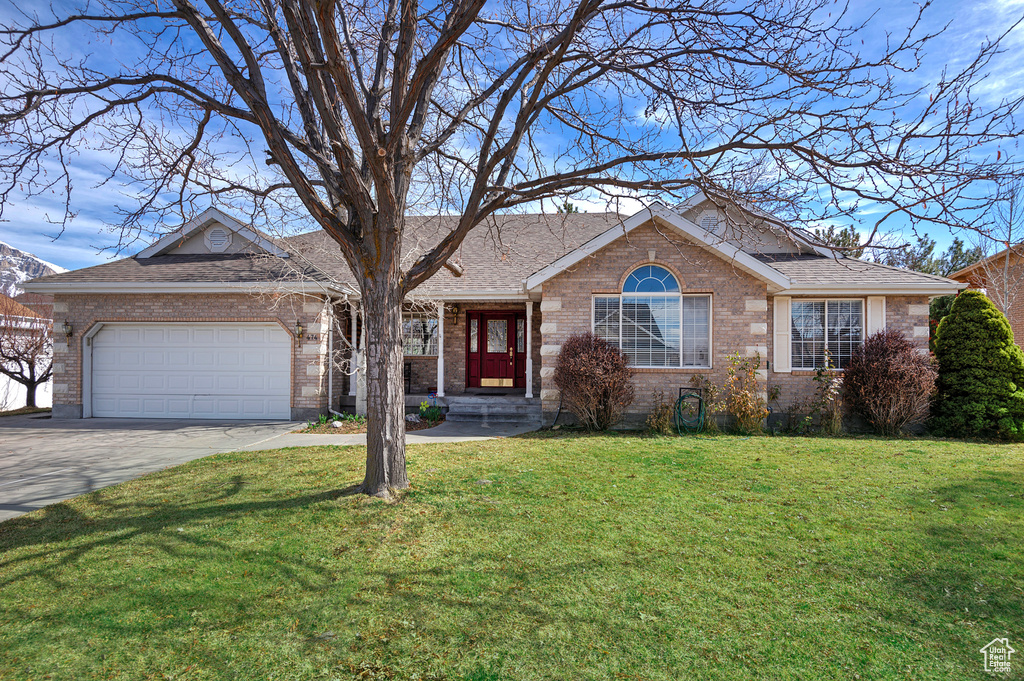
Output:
791 300 864 369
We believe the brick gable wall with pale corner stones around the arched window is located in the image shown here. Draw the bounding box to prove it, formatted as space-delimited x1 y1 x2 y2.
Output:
541 225 770 425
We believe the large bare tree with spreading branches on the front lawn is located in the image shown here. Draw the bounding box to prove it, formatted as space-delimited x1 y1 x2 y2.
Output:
0 0 1021 497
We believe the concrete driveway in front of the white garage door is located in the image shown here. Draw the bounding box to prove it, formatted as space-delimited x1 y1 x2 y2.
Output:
0 415 299 521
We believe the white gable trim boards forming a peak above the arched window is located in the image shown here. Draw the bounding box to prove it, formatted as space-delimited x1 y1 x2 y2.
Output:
523 204 792 293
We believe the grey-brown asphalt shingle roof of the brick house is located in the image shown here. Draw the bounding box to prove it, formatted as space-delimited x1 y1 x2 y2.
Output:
25 213 954 295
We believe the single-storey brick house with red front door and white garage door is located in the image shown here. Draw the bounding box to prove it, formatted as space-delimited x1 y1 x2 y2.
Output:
26 195 963 422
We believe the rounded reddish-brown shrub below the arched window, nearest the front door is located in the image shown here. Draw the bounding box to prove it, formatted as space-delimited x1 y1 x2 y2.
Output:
554 332 634 430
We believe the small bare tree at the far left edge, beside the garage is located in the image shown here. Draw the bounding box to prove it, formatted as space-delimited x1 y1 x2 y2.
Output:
0 295 53 407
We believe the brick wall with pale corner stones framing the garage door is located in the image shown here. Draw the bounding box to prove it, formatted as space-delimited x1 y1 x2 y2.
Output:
53 293 329 419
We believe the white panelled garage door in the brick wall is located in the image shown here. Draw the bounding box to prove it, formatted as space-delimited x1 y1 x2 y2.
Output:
92 324 292 419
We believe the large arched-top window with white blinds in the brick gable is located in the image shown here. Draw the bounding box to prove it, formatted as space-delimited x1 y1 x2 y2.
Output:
594 265 711 368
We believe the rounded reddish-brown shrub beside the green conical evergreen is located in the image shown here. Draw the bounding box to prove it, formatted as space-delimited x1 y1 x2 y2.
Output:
843 329 936 436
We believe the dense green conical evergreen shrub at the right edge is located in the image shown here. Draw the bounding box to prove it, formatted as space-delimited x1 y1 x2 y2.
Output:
931 291 1024 439
